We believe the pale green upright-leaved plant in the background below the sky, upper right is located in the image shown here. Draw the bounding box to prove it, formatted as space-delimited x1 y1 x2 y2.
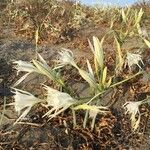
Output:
111 7 144 47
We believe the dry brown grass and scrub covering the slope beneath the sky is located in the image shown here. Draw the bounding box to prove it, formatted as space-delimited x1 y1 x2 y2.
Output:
1 0 149 43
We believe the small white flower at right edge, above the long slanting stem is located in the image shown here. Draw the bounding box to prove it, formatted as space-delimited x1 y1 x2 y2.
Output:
126 52 144 70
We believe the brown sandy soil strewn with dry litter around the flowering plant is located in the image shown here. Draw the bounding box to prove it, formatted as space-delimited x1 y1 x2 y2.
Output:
0 6 150 150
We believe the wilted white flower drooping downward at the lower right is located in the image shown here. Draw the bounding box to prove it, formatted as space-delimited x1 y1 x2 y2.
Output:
123 101 143 131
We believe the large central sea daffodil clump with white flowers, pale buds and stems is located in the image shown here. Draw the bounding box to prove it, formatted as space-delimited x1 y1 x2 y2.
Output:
9 33 144 130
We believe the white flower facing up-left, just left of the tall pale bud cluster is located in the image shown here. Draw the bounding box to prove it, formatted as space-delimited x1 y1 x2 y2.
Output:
58 49 77 68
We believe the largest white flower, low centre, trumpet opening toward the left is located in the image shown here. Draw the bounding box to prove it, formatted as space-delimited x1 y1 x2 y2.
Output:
43 85 76 119
